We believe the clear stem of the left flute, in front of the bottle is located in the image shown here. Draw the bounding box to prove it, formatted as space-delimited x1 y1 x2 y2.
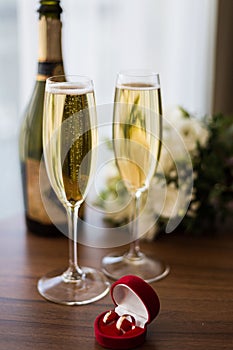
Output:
65 206 85 281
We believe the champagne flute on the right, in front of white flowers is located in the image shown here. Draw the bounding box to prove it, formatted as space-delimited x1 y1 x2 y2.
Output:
102 70 169 282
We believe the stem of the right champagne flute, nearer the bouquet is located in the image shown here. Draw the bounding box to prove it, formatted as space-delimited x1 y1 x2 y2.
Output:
127 191 143 260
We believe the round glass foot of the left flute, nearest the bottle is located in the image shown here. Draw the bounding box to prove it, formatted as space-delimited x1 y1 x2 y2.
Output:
37 267 110 305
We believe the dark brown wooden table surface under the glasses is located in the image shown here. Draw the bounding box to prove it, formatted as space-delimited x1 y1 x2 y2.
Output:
0 217 233 350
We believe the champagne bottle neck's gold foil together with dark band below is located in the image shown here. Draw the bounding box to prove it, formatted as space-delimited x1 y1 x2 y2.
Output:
37 15 64 81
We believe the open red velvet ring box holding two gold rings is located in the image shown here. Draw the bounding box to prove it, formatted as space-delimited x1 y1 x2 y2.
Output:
94 275 160 349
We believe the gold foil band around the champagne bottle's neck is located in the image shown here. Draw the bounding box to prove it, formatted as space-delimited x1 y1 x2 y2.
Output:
38 16 62 62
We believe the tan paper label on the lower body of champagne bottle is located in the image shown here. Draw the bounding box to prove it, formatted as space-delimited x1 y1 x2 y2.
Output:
26 158 66 225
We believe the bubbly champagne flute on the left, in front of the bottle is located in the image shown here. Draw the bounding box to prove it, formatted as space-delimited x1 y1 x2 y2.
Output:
38 76 109 305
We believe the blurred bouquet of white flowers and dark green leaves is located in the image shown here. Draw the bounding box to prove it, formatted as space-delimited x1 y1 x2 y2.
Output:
97 107 233 239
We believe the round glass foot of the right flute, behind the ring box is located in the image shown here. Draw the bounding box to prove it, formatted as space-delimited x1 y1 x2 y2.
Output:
102 253 170 283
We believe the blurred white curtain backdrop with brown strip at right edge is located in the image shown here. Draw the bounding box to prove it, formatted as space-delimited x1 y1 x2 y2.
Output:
0 0 233 219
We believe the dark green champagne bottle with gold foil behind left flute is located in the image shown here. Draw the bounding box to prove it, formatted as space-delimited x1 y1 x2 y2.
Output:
19 0 64 235
